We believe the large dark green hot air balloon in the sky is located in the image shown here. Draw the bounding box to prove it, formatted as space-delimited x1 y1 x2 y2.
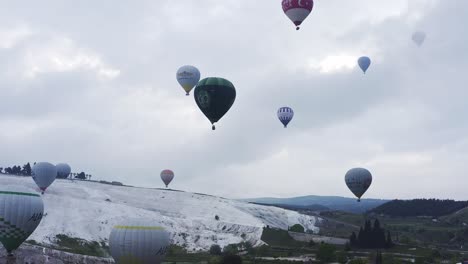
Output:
195 77 236 130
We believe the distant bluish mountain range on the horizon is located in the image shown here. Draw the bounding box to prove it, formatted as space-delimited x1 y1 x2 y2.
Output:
242 195 389 213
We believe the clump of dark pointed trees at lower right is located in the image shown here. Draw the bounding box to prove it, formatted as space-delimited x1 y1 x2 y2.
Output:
349 219 394 248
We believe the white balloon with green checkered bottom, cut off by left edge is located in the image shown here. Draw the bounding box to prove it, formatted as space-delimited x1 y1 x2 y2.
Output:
0 186 44 256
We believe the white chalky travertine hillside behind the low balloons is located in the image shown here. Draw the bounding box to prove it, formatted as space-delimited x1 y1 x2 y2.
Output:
0 175 318 251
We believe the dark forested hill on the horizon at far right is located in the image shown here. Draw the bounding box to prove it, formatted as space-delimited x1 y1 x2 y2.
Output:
370 199 468 217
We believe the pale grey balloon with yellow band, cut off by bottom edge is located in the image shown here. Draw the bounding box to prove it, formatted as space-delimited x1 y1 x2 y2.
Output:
109 222 169 264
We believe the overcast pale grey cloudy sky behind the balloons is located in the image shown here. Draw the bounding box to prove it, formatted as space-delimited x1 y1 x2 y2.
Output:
0 0 468 200
